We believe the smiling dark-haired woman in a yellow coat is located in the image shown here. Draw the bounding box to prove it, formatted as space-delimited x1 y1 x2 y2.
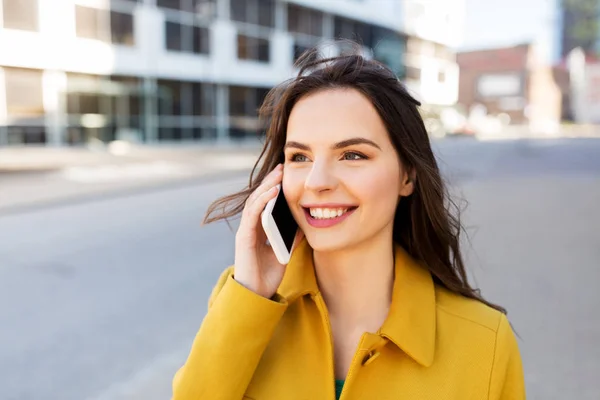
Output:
173 48 525 400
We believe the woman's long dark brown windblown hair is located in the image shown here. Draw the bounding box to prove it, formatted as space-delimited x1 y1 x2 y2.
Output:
204 45 506 313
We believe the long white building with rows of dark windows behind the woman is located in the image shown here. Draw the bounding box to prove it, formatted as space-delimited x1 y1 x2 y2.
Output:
0 0 464 145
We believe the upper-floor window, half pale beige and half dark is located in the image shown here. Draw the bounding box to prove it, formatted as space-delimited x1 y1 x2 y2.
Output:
75 5 135 46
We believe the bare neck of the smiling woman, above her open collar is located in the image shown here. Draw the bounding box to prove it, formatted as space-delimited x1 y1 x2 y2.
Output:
313 234 394 333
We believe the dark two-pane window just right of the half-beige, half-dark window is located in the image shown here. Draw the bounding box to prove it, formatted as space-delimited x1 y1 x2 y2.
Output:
165 21 210 54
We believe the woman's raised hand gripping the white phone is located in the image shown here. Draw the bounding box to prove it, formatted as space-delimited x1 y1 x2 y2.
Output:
234 164 301 298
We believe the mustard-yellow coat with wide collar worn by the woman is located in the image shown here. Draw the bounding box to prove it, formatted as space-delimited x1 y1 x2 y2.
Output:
173 240 525 400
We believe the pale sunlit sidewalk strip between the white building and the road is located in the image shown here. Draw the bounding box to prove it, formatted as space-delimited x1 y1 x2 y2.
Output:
0 142 261 215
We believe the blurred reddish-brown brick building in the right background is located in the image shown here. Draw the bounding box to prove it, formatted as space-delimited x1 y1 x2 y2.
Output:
457 44 565 131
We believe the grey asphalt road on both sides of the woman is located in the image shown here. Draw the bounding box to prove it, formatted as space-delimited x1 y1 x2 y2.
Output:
0 139 600 400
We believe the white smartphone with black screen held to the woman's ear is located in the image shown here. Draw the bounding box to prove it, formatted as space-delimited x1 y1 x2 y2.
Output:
261 185 298 264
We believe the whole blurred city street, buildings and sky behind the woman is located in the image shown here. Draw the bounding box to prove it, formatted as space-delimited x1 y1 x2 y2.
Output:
0 0 600 400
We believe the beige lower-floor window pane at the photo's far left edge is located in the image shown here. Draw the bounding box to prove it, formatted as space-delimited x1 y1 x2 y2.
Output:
4 67 44 117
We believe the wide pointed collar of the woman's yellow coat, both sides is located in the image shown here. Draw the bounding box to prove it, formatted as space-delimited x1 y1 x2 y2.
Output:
279 239 436 367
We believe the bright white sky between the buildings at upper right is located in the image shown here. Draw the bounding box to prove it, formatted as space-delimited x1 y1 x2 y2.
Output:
459 0 556 57
